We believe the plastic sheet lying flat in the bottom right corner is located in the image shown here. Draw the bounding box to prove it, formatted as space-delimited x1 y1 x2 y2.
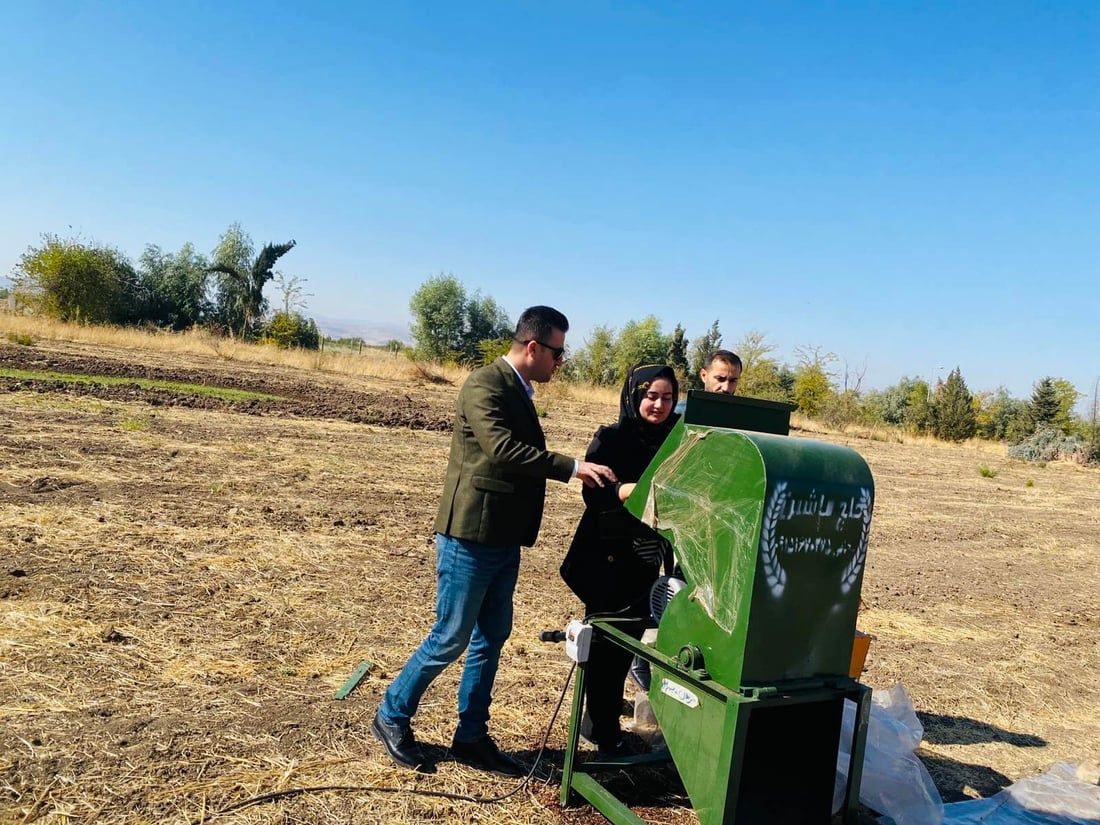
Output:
944 762 1100 825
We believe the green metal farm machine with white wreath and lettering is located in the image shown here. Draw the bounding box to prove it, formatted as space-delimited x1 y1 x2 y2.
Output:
561 392 875 825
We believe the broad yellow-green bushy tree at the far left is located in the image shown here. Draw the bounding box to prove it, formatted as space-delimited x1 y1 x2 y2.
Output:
13 234 139 323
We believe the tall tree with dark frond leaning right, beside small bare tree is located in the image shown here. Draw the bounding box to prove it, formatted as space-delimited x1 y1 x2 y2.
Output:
209 223 296 338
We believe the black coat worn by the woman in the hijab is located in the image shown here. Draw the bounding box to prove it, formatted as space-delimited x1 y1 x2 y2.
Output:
561 414 679 615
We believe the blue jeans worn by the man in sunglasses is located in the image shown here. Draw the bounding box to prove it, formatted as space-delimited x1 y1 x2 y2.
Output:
378 534 519 741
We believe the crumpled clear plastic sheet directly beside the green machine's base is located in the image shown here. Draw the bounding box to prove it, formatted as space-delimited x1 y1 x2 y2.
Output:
833 684 944 825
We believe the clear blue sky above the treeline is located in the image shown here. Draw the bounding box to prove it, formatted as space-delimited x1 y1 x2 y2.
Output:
0 0 1100 397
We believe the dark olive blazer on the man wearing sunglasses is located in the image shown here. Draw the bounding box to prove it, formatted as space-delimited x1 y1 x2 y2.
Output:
436 358 574 547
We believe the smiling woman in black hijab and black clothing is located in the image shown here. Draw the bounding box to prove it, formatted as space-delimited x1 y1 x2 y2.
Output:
561 363 680 756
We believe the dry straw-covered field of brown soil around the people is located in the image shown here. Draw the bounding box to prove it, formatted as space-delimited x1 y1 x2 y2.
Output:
0 316 1100 825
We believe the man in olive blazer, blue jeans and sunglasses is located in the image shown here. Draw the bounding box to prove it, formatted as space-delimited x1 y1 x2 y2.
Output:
371 307 615 776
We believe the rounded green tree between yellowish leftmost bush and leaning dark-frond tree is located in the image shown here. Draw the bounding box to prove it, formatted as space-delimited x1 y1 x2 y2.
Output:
138 243 212 330
